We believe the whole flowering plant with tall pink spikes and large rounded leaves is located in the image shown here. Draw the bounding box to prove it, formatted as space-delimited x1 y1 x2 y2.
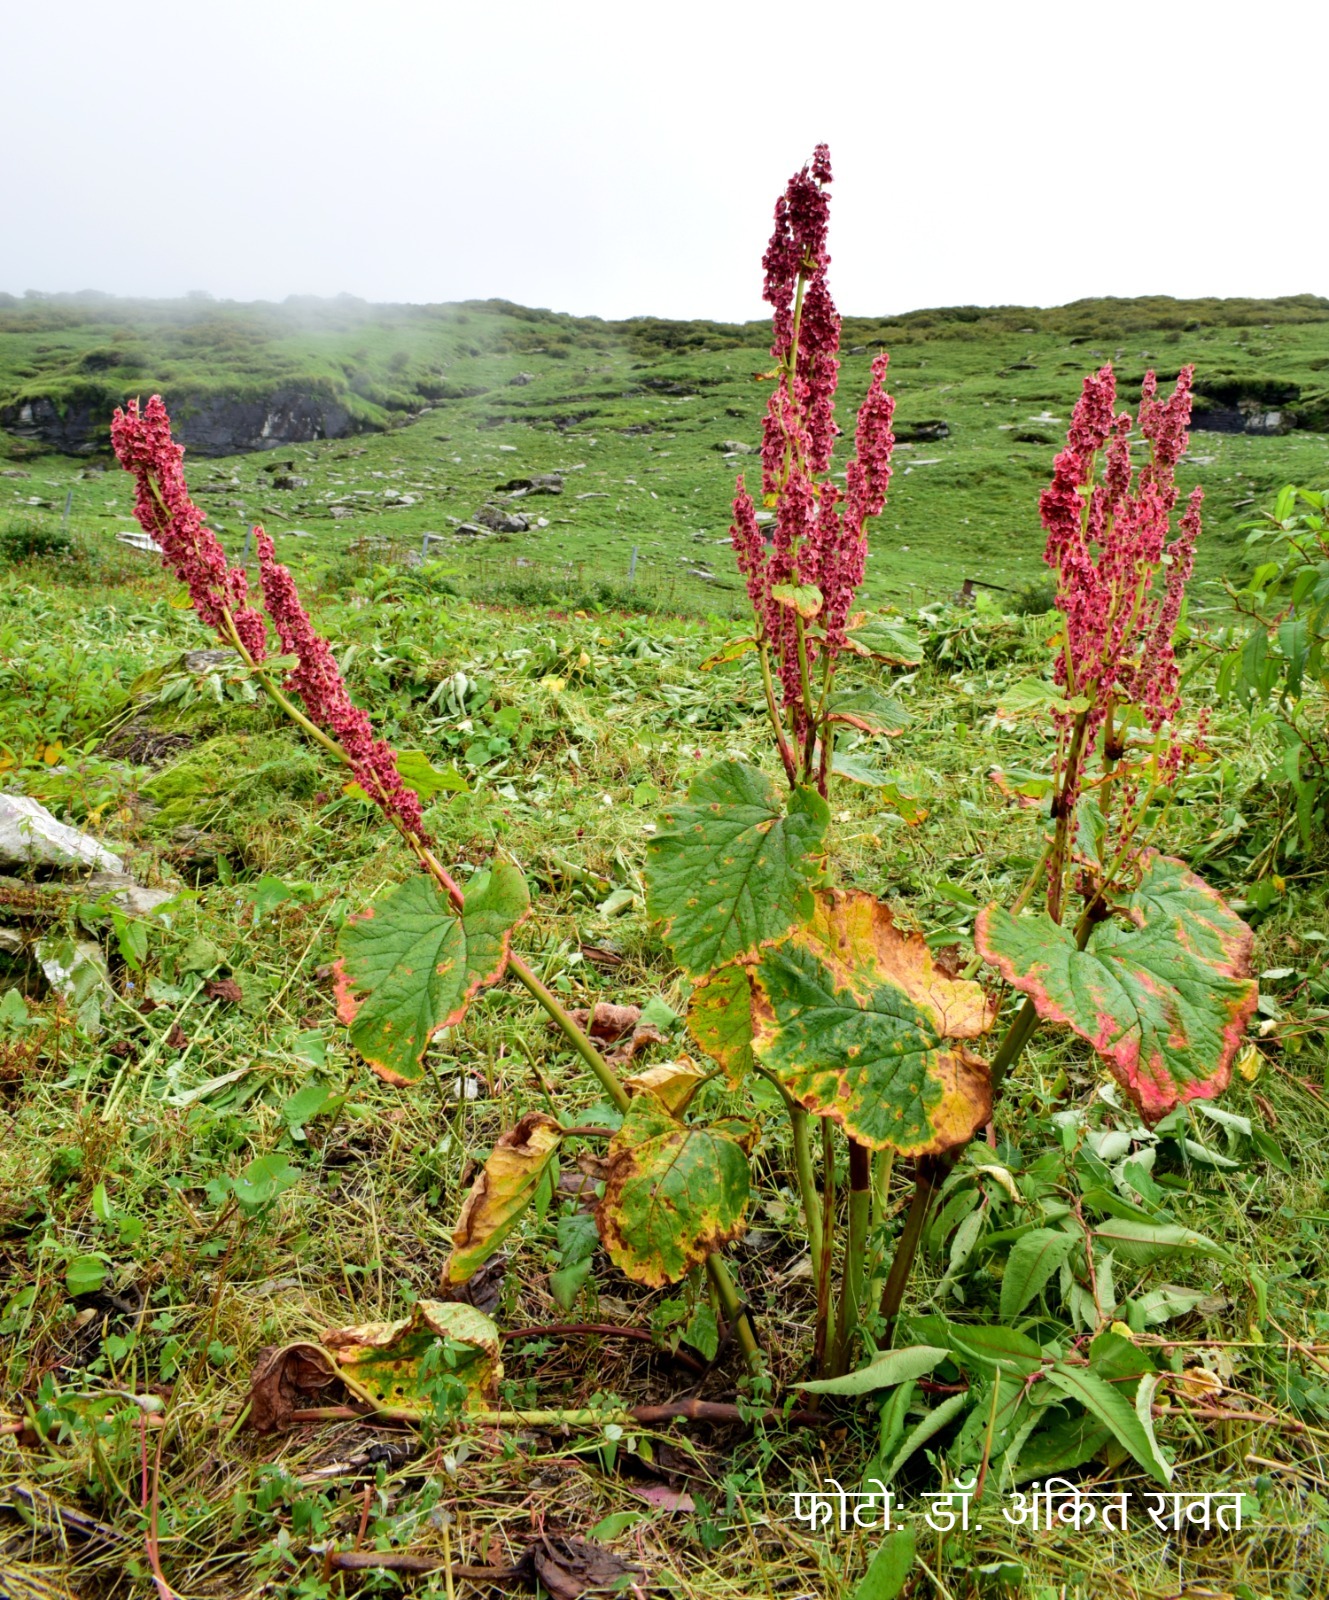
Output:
112 146 1255 1408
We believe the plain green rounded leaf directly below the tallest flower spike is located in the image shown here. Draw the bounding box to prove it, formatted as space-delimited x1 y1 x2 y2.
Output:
646 762 830 974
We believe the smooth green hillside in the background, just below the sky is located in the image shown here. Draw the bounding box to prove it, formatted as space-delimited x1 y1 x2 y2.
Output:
0 284 1329 613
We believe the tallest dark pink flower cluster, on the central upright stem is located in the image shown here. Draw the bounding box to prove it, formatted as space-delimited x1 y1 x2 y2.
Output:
729 144 896 738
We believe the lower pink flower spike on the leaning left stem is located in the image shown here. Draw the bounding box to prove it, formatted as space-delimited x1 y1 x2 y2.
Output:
254 528 429 843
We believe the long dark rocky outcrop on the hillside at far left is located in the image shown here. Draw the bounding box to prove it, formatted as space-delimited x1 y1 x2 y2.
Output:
0 389 369 456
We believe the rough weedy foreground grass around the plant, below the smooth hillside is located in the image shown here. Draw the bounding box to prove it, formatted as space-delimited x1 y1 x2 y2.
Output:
0 517 1329 1600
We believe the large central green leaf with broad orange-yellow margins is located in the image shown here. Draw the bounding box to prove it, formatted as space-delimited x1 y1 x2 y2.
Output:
753 890 993 1155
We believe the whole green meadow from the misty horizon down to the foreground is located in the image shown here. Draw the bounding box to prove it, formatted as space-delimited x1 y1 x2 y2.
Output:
0 291 1329 1600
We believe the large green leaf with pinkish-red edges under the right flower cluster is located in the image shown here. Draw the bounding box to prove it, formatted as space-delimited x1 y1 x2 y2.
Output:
976 851 1257 1122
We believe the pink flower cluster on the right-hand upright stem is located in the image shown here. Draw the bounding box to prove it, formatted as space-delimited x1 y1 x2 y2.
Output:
1040 365 1204 761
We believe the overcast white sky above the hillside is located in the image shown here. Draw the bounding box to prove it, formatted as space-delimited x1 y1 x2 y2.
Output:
0 0 1329 320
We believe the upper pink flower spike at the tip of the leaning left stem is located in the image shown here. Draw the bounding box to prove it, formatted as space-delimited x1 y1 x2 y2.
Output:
110 395 267 661
